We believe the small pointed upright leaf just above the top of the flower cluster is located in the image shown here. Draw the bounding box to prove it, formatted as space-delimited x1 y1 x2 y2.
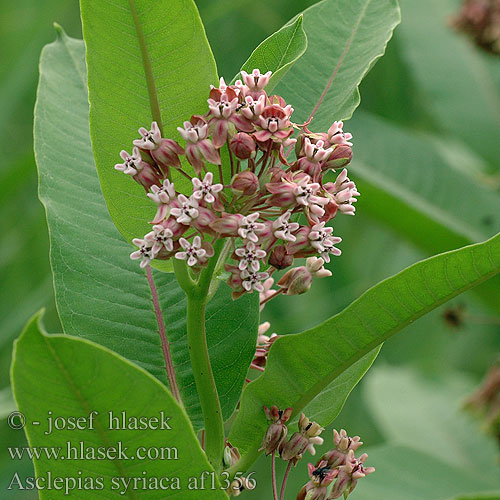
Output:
234 15 307 94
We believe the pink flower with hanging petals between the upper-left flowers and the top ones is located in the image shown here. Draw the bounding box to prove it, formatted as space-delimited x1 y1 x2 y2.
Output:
177 115 221 175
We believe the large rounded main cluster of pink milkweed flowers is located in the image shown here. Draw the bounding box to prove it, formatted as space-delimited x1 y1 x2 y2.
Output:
115 69 359 298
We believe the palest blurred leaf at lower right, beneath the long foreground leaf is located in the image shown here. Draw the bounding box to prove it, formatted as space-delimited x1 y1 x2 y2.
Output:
363 367 500 472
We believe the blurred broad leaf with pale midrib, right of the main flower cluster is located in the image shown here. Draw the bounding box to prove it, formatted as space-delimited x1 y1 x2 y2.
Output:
347 111 500 310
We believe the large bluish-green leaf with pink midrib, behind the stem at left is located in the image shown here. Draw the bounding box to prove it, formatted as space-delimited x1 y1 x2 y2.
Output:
35 29 259 429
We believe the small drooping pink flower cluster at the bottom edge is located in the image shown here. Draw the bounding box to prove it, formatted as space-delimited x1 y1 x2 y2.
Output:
260 406 375 500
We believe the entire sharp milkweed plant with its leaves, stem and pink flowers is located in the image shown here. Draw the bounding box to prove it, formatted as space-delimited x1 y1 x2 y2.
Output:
12 0 500 500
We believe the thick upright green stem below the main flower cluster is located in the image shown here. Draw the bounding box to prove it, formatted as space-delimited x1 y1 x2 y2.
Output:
186 240 224 472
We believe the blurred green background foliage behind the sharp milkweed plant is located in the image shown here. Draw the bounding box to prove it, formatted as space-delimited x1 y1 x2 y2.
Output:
0 0 500 500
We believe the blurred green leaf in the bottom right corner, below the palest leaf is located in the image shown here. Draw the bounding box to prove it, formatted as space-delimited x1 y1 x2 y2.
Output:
346 445 498 500
